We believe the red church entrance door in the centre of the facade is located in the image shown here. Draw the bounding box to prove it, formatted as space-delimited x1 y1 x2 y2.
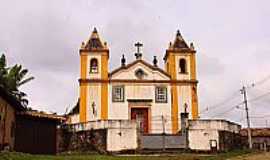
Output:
131 108 149 133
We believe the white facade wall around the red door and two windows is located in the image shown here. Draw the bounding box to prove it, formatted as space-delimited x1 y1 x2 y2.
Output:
109 83 171 133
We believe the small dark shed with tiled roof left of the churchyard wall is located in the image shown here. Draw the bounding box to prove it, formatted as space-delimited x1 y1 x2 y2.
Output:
15 111 65 154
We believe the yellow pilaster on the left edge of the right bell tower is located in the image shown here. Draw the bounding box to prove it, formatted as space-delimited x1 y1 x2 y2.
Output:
168 54 179 133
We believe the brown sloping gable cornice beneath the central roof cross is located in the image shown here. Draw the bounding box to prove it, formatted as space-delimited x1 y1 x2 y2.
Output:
109 59 171 77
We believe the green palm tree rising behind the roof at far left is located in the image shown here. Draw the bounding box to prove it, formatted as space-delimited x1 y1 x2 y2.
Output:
0 54 34 107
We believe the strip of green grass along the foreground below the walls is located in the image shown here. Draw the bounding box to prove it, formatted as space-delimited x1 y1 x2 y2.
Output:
0 151 255 160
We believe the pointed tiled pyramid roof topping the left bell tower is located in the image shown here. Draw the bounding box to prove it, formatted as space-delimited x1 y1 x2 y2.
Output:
84 28 106 50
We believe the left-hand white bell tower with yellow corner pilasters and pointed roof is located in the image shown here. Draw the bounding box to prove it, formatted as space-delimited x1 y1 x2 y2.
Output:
79 28 109 122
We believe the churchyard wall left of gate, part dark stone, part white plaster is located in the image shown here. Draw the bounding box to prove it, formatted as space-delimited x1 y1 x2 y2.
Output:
58 120 138 153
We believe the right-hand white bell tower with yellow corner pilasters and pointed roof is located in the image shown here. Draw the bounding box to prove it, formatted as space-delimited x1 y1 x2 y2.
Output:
164 30 198 133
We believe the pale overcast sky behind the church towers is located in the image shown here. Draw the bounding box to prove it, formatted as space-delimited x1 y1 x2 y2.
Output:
0 0 270 126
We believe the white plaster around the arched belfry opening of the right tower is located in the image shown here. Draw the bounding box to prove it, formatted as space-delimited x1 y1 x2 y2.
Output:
175 54 191 80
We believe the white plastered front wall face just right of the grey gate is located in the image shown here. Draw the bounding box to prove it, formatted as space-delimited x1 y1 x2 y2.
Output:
188 129 219 151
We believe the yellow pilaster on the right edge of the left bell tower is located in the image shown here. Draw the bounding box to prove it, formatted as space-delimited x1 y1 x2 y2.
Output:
100 54 108 120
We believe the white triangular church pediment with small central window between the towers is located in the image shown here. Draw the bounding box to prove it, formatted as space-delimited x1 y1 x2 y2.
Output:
110 60 170 80
